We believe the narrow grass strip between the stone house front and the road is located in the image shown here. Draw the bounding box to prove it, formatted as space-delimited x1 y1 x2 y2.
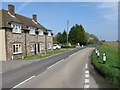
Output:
23 49 66 60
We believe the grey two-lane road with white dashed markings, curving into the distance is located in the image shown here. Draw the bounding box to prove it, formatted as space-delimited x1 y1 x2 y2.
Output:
2 47 111 88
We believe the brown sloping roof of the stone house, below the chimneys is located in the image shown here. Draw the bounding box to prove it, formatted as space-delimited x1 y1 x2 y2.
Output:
0 9 47 30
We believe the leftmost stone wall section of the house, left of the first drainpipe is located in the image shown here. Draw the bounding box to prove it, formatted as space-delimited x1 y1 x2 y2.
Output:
6 29 25 60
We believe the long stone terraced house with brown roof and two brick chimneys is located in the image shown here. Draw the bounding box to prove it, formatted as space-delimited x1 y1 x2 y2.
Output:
0 5 53 60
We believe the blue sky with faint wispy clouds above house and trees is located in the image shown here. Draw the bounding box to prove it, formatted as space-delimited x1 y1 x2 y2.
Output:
2 2 118 41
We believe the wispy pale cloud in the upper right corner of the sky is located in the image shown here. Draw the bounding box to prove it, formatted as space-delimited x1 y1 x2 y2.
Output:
97 2 118 21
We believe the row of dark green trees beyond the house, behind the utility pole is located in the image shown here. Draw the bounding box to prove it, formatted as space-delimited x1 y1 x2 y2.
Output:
54 24 99 45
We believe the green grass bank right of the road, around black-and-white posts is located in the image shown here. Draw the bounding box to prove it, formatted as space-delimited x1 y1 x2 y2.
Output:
91 43 120 88
